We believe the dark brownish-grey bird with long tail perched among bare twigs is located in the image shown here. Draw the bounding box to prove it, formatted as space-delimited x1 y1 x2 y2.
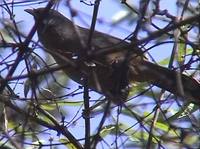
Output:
25 8 200 104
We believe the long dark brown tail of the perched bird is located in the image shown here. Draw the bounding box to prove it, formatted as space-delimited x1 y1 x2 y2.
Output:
130 60 200 104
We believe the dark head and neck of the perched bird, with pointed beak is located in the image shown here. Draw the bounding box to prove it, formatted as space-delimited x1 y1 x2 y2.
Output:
25 8 81 51
